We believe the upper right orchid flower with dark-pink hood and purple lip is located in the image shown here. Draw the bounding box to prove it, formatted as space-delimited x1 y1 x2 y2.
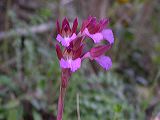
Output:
81 16 114 44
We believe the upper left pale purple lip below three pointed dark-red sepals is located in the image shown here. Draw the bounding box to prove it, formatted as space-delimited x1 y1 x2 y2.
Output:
56 33 77 47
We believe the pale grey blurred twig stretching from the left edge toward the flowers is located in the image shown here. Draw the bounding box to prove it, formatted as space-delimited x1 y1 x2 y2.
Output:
0 22 54 41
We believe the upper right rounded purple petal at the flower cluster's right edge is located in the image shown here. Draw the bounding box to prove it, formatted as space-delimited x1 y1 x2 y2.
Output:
101 29 114 44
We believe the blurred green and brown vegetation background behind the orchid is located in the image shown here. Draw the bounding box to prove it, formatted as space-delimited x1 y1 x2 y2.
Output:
0 0 160 120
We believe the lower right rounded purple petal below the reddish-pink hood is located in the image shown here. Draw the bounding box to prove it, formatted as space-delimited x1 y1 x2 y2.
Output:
94 56 112 70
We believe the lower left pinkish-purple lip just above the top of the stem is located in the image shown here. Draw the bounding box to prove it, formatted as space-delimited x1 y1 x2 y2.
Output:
60 58 81 72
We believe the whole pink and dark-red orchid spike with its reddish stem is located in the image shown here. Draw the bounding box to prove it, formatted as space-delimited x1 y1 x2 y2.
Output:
56 16 114 120
